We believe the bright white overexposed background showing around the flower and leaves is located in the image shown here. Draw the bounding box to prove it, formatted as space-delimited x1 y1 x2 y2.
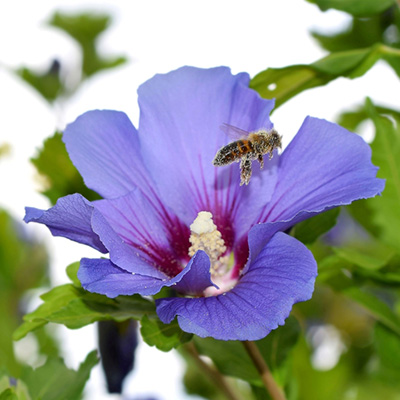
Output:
0 0 400 400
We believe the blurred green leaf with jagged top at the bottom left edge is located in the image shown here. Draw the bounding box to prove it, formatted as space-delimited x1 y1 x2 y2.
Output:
21 351 99 400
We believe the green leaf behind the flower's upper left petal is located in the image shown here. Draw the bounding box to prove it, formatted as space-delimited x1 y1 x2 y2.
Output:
31 132 100 204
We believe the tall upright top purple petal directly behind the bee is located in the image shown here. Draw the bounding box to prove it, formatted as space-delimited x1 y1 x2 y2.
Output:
139 67 276 241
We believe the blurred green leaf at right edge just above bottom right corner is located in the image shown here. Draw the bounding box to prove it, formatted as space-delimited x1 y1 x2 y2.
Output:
374 323 400 371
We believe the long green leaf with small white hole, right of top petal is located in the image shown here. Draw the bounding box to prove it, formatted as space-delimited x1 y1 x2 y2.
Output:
250 44 400 108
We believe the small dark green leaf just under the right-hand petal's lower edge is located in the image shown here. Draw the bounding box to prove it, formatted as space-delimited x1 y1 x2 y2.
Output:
291 208 340 244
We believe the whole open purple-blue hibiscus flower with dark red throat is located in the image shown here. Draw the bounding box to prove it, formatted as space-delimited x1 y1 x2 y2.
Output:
25 67 384 340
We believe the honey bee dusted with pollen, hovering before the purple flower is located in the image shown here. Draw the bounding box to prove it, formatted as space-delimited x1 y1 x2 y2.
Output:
213 124 282 186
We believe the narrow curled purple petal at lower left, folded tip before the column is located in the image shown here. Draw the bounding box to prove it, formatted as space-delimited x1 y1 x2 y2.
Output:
78 251 215 297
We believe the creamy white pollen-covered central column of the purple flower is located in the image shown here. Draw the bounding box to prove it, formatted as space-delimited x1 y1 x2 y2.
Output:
189 211 229 276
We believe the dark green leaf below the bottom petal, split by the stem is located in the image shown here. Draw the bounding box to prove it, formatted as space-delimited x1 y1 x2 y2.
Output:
194 317 300 386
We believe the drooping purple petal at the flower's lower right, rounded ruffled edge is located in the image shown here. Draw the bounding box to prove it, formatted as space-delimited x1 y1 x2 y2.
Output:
156 232 317 340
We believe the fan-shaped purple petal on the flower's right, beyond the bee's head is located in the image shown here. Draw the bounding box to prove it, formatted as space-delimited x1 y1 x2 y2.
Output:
259 117 385 225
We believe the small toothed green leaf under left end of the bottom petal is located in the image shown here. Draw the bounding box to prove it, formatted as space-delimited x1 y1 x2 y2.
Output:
140 315 193 351
